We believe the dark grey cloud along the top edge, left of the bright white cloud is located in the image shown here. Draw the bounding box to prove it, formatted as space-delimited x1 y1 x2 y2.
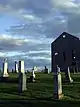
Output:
0 0 52 16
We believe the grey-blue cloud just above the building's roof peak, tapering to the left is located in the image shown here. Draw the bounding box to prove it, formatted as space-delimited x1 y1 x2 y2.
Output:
6 12 67 38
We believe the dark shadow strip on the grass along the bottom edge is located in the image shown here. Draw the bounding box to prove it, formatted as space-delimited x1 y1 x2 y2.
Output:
0 99 80 107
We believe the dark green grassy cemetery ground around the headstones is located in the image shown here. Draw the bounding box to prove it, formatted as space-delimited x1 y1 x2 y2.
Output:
0 73 80 107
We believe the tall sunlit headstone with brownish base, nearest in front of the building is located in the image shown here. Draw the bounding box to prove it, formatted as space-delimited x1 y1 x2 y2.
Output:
54 65 63 99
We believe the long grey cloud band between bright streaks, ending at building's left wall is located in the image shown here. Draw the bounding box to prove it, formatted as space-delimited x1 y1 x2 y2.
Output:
0 39 50 52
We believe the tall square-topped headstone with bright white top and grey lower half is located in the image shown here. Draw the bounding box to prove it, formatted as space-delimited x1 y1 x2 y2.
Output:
19 61 27 93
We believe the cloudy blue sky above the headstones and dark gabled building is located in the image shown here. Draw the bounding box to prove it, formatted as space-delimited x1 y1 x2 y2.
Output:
0 0 80 69
